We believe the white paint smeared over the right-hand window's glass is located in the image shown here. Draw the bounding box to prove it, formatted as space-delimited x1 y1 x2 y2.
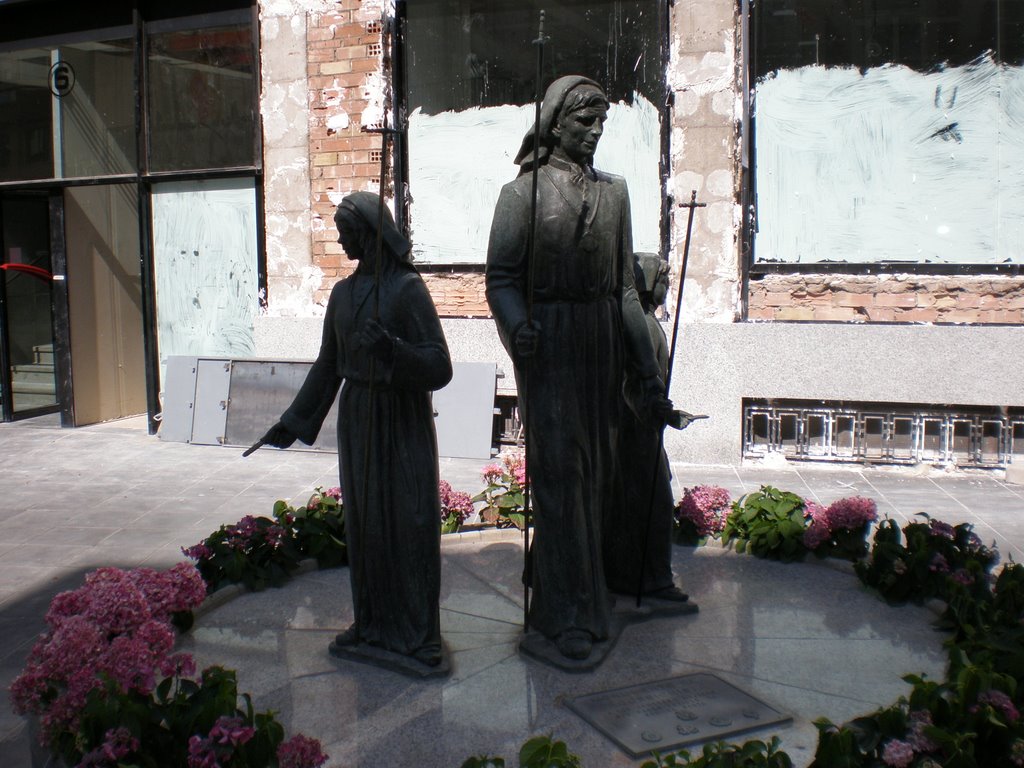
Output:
756 57 1024 264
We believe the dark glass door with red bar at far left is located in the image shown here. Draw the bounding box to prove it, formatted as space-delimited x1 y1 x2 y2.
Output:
0 194 58 421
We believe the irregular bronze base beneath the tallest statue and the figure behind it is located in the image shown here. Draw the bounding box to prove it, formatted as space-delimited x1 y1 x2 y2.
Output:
519 595 699 672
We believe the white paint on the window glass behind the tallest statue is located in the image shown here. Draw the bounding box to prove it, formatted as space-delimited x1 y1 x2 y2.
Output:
409 94 662 264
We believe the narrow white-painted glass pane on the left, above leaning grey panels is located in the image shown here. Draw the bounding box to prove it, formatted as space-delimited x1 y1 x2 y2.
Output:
153 179 259 387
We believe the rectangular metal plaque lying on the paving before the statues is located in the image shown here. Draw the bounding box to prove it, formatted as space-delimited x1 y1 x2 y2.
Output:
568 674 793 758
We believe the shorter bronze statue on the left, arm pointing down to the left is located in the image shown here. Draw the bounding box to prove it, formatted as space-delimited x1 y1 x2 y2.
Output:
258 191 452 667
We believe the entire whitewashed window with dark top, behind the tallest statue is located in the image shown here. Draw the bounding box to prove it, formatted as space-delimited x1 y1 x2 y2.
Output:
404 0 666 265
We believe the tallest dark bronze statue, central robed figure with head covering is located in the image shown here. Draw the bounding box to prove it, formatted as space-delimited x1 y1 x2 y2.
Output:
486 76 672 659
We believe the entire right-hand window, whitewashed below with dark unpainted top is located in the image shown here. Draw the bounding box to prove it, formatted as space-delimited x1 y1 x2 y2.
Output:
752 0 1024 265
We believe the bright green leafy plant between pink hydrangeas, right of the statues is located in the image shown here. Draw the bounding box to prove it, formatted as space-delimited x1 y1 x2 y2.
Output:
722 485 807 561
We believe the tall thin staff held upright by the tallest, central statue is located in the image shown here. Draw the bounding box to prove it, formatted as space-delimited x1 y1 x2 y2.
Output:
522 10 544 632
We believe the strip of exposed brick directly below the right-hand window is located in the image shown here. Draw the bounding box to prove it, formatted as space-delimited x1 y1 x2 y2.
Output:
748 274 1024 325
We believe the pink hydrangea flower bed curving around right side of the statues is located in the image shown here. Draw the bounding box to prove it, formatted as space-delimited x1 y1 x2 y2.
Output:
464 485 1024 768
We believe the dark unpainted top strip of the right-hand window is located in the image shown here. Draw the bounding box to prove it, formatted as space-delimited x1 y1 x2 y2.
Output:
754 0 1024 77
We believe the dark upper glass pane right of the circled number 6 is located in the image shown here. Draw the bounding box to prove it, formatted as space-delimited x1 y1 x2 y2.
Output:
148 25 255 171
